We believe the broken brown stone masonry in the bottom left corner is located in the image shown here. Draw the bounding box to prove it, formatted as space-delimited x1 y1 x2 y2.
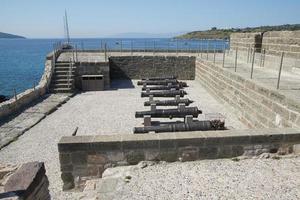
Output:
0 162 50 200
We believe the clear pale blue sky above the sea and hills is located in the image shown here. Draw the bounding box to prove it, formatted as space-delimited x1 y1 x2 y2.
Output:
0 0 300 38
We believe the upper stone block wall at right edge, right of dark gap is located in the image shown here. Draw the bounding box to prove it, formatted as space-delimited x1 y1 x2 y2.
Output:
262 31 300 59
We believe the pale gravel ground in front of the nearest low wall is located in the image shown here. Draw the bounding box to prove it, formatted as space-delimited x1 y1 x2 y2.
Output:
112 157 300 200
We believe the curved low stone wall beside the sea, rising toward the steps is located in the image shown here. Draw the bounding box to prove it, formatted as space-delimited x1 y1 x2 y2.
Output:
0 53 53 121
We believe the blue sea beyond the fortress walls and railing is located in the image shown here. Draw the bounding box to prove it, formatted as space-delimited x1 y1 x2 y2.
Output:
0 38 228 97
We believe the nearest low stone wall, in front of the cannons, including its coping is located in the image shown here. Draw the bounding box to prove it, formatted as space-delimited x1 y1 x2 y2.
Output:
58 129 300 190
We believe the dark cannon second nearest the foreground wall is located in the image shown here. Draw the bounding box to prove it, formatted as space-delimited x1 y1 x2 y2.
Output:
135 107 202 119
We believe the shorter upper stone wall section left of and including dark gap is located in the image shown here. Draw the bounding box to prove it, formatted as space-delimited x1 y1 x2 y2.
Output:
230 32 262 52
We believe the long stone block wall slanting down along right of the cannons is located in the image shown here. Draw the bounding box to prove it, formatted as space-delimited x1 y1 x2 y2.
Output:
196 61 300 128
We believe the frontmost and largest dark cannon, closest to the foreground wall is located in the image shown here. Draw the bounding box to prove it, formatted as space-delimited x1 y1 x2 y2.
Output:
133 120 225 133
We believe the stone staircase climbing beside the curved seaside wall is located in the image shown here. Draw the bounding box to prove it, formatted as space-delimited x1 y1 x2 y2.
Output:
50 62 75 93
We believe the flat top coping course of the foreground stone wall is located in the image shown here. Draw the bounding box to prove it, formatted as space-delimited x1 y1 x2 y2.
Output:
58 128 300 152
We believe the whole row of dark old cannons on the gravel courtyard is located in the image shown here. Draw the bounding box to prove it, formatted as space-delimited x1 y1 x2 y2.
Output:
134 76 225 133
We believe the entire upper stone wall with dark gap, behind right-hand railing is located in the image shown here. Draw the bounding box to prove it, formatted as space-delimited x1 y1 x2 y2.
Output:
229 31 300 74
